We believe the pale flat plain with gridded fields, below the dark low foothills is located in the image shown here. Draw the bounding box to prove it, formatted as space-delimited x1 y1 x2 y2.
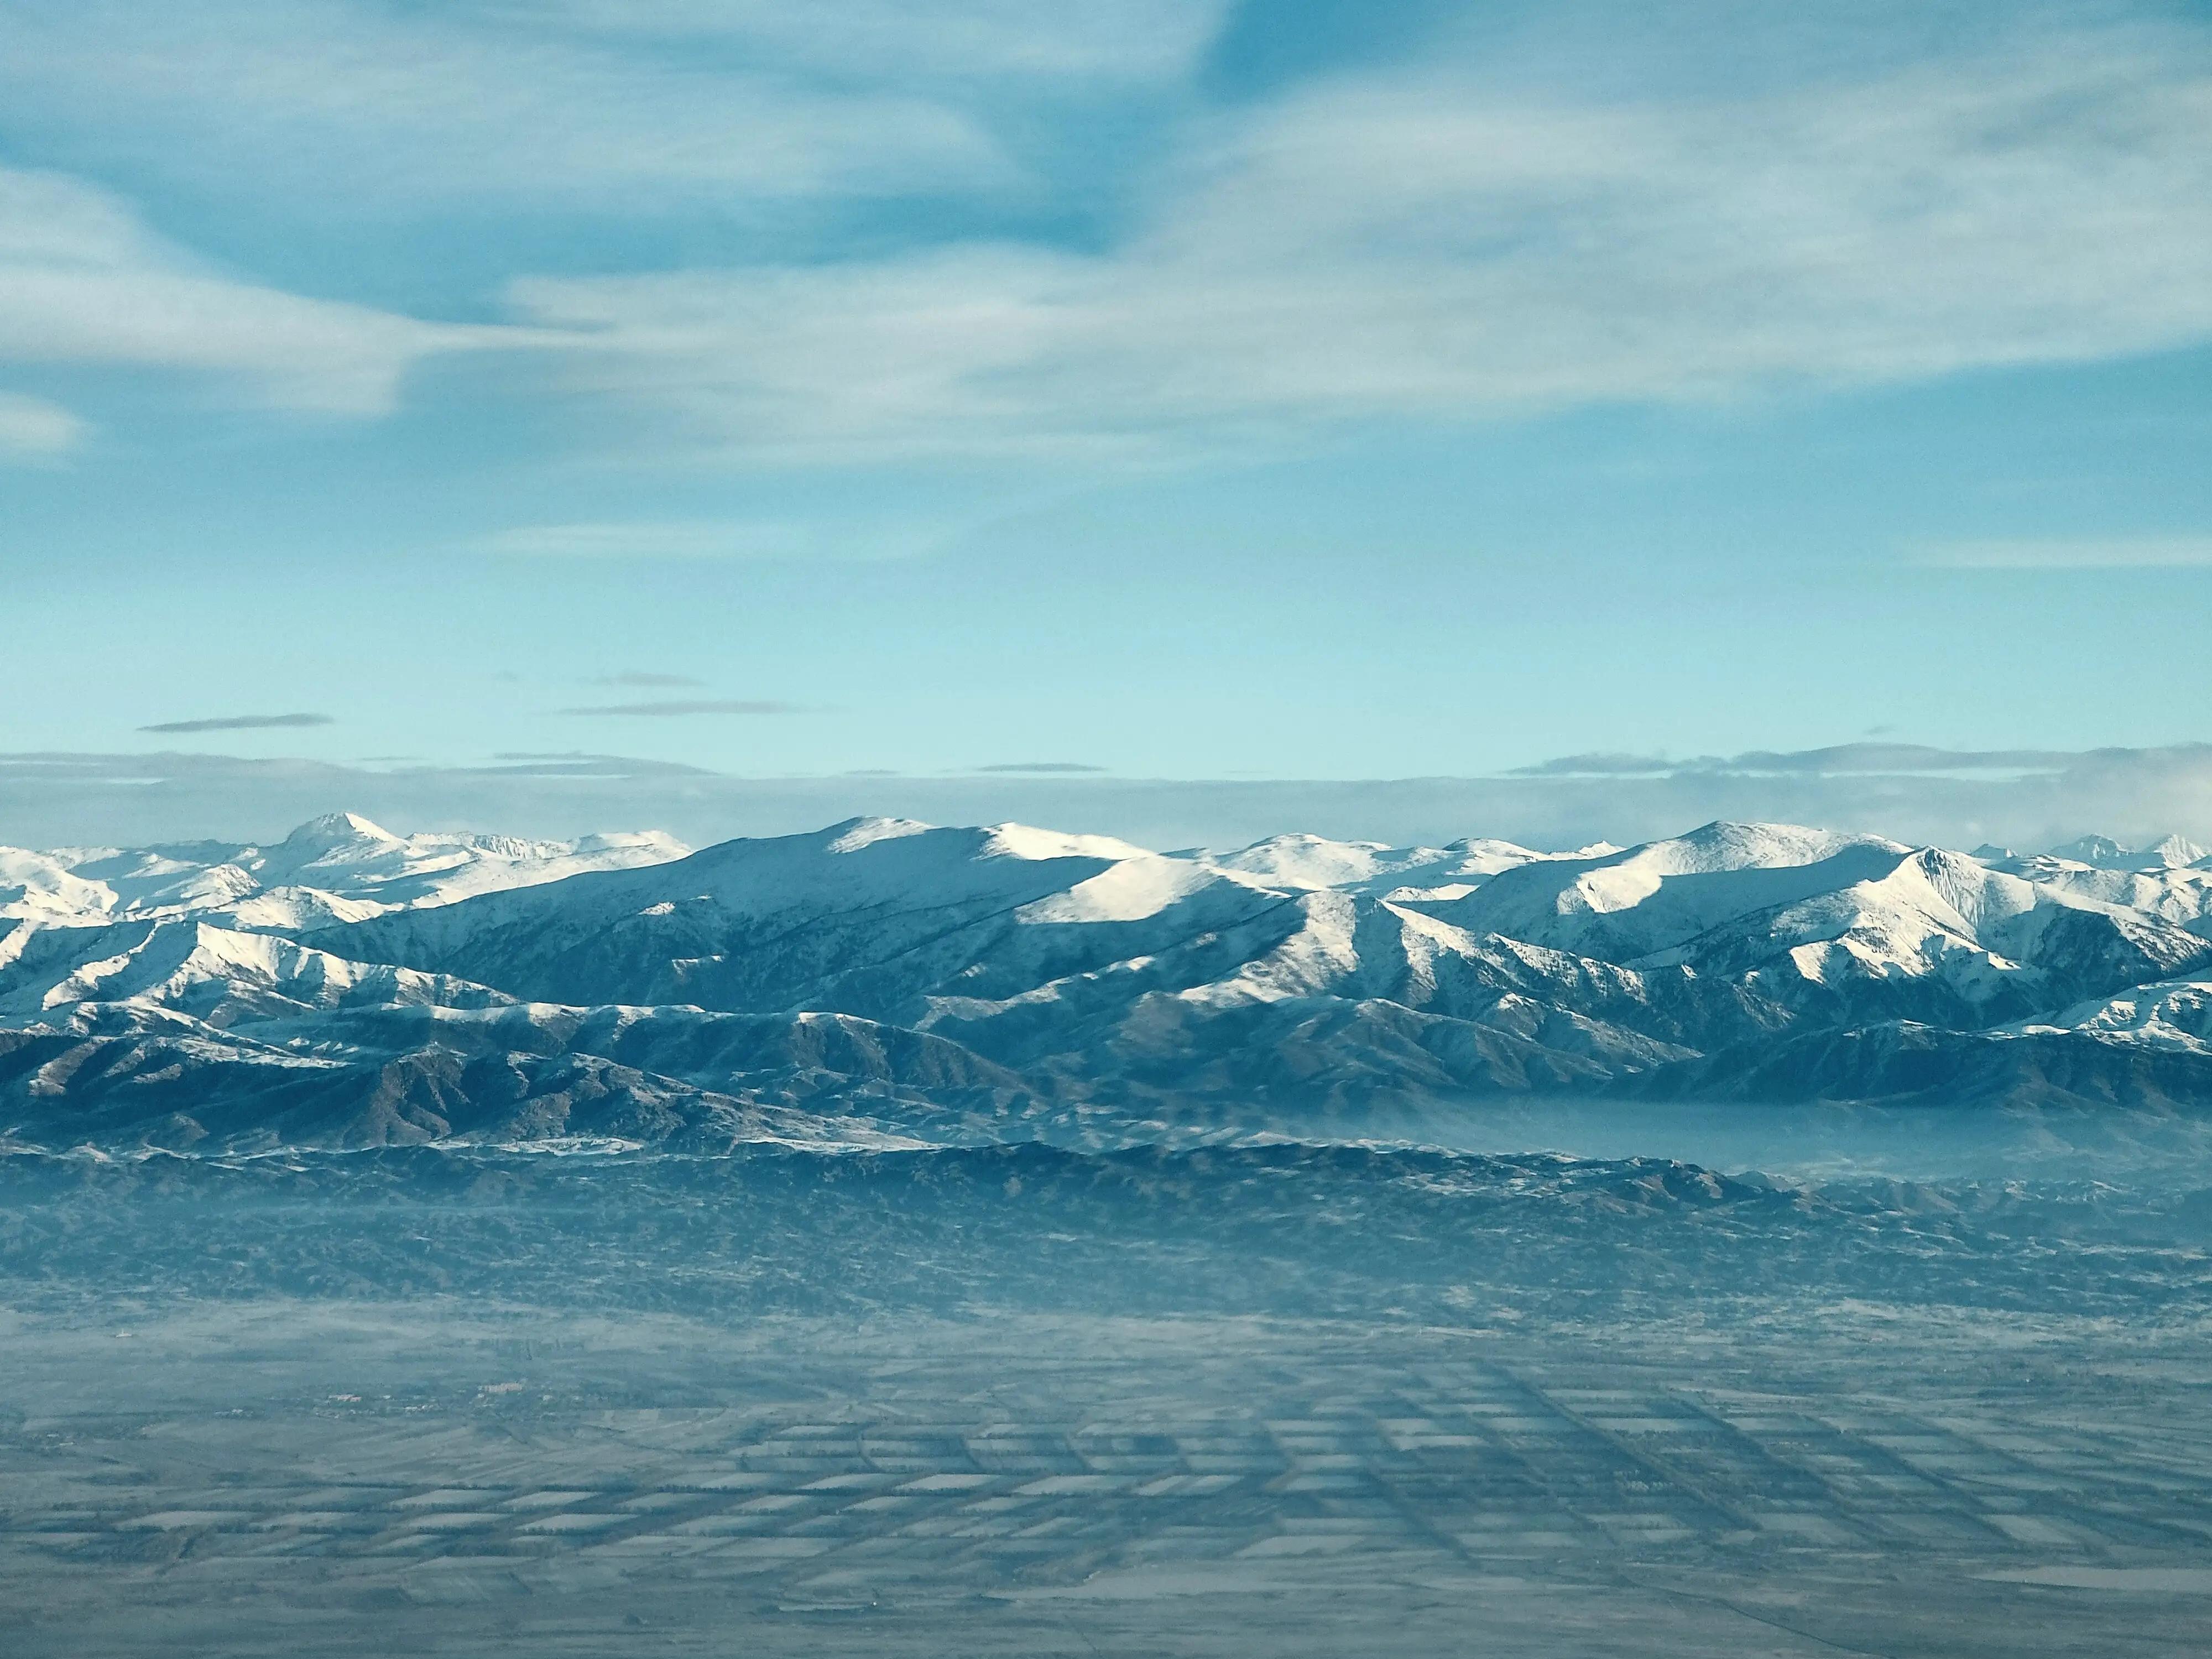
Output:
0 1298 2212 1659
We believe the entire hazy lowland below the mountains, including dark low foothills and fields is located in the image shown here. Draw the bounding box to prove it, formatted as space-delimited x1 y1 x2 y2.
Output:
0 1119 2212 1659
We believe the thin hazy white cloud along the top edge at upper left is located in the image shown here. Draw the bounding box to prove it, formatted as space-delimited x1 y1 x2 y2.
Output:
0 0 1015 219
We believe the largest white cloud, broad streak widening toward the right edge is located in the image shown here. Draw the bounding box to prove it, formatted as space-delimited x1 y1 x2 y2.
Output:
511 33 2212 458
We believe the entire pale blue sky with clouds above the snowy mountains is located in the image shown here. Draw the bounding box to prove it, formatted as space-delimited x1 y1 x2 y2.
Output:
0 0 2212 843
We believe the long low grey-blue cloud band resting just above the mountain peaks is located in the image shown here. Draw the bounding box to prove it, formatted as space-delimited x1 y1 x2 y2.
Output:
0 743 2212 849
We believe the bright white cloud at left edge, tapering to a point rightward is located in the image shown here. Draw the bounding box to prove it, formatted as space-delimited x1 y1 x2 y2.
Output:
0 168 504 416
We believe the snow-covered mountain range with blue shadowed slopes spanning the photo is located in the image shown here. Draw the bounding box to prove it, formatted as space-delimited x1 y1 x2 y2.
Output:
0 816 2212 1144
